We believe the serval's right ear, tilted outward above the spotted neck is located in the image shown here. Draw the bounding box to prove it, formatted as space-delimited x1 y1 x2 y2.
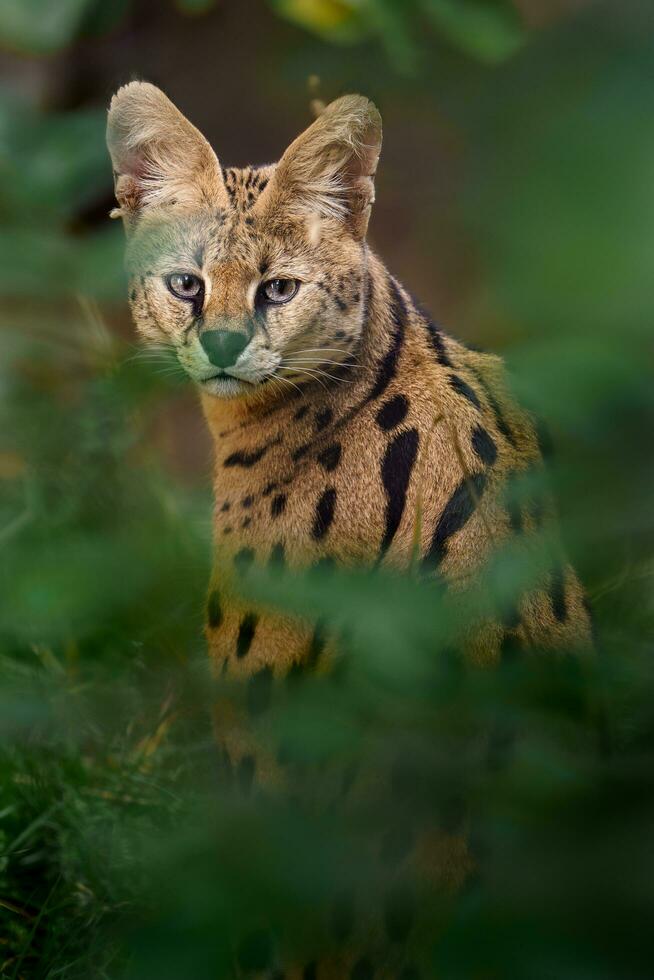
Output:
257 95 382 239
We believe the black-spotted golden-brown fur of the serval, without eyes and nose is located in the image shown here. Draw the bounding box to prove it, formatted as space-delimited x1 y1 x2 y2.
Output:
108 83 589 980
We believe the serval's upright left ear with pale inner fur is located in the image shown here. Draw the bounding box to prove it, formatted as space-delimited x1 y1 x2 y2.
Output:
107 82 228 230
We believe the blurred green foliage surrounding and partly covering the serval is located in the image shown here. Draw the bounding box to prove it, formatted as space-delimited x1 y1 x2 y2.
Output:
0 0 654 980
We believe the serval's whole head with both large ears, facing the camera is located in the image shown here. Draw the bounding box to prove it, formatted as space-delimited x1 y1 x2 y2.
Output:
108 83 381 398
